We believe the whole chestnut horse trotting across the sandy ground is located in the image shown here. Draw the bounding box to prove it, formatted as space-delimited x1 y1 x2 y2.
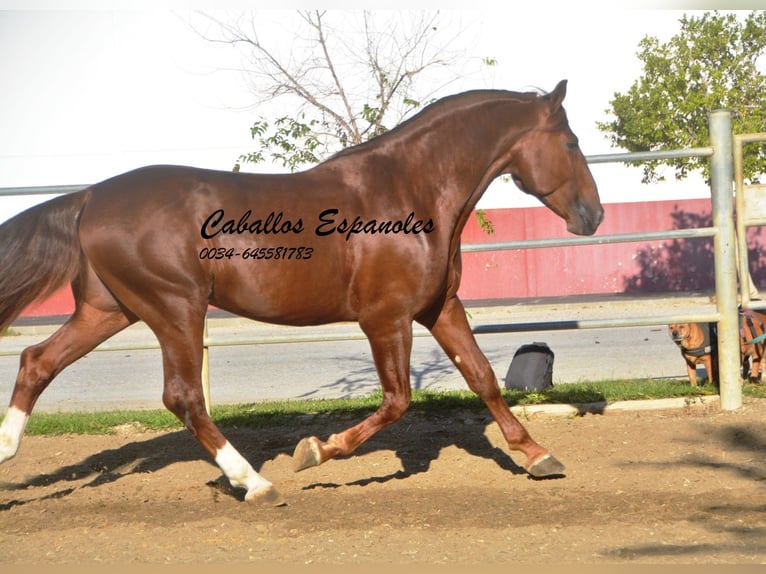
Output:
0 81 603 504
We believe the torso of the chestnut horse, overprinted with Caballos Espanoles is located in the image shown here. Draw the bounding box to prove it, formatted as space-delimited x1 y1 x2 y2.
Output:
81 168 450 324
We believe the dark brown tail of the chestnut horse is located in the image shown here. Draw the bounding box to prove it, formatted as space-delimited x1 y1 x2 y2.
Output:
0 191 89 331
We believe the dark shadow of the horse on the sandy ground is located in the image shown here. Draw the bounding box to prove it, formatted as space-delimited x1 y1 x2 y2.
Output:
0 404 536 512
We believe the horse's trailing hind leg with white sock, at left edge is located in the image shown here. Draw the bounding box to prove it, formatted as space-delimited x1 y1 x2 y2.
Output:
0 302 133 462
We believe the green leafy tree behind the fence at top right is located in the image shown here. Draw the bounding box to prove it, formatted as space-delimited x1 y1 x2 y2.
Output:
597 11 766 183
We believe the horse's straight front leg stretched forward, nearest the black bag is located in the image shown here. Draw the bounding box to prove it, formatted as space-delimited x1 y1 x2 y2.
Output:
430 297 564 477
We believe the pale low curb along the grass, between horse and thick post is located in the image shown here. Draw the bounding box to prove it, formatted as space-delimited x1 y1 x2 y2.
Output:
511 395 721 419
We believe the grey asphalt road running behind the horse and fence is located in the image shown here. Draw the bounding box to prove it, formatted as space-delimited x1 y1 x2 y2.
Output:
0 299 706 411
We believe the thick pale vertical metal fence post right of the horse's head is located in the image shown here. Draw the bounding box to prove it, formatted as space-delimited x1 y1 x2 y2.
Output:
709 110 742 410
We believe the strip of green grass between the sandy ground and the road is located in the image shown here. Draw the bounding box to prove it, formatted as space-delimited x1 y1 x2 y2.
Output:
15 380 752 435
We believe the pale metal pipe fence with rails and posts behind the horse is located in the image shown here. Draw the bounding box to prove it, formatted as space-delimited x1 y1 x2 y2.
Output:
0 110 766 410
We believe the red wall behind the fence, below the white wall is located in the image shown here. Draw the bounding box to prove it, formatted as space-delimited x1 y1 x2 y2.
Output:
23 199 766 316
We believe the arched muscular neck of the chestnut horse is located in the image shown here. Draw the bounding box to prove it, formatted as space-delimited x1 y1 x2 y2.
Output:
318 95 536 237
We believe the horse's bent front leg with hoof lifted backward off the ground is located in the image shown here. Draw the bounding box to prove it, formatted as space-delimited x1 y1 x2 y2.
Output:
293 319 412 472
